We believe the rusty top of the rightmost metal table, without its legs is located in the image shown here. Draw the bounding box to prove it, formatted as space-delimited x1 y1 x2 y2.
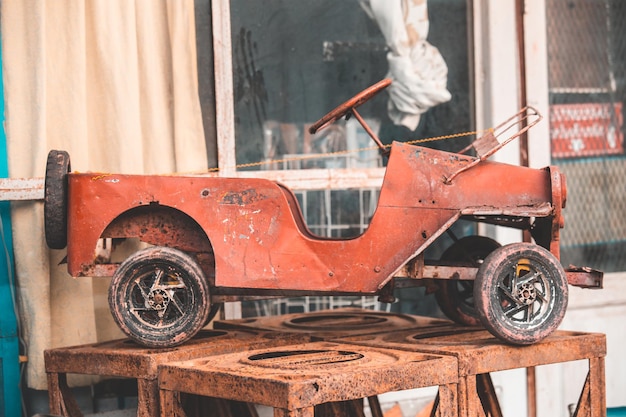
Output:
335 324 606 376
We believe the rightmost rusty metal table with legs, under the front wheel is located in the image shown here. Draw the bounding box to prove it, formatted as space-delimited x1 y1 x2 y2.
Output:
335 324 606 417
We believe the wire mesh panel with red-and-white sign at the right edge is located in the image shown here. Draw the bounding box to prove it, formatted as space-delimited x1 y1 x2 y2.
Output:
546 0 626 272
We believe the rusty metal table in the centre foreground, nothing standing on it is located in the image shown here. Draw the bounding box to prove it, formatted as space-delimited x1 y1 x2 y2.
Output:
159 341 458 417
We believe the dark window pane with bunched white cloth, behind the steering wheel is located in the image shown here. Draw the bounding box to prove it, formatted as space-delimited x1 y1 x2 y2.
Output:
231 0 472 169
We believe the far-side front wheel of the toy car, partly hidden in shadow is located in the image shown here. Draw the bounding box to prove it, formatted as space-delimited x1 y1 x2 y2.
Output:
435 236 501 326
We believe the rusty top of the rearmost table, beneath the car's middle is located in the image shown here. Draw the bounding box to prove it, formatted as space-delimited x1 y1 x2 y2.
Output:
214 307 451 340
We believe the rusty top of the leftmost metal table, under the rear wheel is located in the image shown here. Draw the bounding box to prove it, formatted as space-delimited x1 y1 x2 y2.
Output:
44 330 310 379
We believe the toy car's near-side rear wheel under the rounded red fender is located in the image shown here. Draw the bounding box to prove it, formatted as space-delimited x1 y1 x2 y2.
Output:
109 247 211 348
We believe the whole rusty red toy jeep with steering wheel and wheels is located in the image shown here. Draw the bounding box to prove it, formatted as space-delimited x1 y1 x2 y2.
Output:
44 80 602 347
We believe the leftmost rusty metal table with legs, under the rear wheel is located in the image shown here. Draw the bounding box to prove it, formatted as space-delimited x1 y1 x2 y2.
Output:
44 330 310 417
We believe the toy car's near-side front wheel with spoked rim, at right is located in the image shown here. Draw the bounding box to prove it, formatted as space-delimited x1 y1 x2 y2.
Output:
474 243 568 345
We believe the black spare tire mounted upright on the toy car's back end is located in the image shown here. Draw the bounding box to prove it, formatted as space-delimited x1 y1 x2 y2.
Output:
43 150 71 249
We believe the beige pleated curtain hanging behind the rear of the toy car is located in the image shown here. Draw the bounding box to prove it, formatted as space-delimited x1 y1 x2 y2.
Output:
2 0 207 389
